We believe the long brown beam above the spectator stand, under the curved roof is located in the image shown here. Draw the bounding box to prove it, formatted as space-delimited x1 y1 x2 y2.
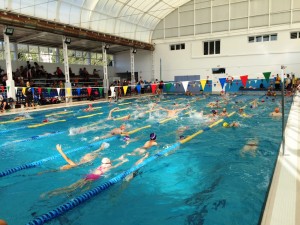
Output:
0 10 154 51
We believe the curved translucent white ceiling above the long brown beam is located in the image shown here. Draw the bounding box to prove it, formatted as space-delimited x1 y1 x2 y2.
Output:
0 0 190 43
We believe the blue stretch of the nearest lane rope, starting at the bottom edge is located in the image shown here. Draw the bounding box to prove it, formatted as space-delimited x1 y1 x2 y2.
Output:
26 142 180 225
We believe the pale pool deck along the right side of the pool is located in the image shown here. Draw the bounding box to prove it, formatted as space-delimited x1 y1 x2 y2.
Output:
261 93 300 225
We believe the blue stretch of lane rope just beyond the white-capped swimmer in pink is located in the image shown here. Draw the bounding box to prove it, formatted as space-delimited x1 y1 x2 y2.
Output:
0 136 119 177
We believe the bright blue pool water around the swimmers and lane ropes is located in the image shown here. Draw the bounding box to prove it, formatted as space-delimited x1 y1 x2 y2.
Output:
0 95 290 225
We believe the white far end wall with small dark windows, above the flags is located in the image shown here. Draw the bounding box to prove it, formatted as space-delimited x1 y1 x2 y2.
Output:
154 25 300 81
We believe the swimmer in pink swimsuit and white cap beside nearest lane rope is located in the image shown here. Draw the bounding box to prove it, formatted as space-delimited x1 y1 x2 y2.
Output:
41 157 128 197
